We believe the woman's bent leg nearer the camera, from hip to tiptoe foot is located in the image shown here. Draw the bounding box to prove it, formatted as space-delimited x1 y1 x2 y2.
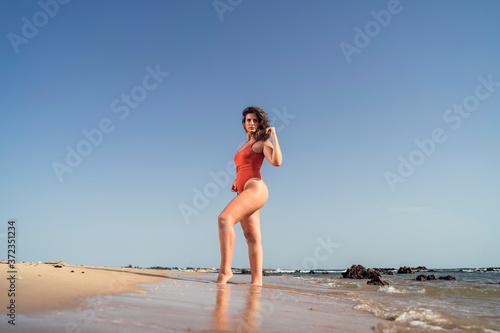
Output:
217 179 268 283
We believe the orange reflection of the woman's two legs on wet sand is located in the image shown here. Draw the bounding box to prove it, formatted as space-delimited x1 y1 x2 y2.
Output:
213 284 262 332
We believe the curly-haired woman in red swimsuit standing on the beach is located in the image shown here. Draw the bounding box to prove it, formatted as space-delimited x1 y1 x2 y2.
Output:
217 106 282 286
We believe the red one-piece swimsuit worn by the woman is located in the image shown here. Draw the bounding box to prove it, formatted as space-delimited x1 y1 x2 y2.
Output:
234 141 264 193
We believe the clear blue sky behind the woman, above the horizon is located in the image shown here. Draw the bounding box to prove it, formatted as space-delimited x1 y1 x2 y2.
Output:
0 0 500 269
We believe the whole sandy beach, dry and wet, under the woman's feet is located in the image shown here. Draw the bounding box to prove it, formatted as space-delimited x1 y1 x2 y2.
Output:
0 263 383 332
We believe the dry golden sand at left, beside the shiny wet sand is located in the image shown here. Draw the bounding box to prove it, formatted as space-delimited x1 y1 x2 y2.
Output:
0 262 205 314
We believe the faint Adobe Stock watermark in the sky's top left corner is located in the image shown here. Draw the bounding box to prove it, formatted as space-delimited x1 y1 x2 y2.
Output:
7 0 70 54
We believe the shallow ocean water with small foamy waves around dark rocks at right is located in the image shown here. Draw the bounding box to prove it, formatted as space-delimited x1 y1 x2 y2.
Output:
264 268 500 332
